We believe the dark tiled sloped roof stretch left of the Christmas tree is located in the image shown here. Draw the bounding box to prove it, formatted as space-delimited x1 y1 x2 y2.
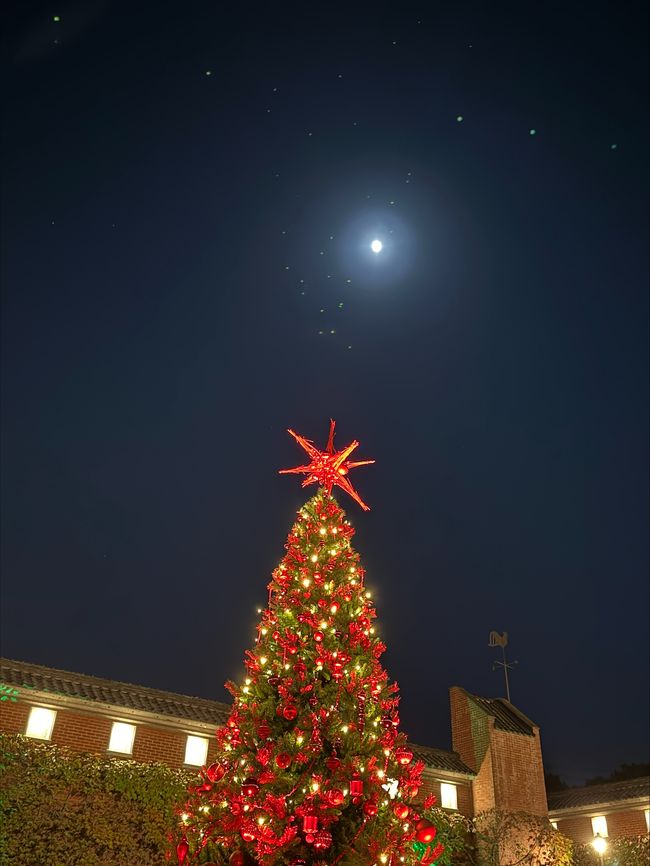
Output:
0 658 230 725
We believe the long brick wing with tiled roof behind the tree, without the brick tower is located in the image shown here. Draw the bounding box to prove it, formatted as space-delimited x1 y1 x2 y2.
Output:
0 659 474 816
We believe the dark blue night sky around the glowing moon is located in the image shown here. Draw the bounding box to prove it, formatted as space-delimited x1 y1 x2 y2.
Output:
2 0 648 783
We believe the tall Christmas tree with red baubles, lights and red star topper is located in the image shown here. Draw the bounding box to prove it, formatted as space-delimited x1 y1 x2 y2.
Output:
174 422 447 866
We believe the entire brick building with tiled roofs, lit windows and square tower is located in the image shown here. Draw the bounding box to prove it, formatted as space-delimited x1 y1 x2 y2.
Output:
0 659 650 842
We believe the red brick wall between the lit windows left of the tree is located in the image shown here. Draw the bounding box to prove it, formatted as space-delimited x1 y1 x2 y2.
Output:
0 701 216 768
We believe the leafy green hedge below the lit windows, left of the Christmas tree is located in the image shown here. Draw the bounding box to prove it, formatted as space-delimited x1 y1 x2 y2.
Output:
0 734 195 866
